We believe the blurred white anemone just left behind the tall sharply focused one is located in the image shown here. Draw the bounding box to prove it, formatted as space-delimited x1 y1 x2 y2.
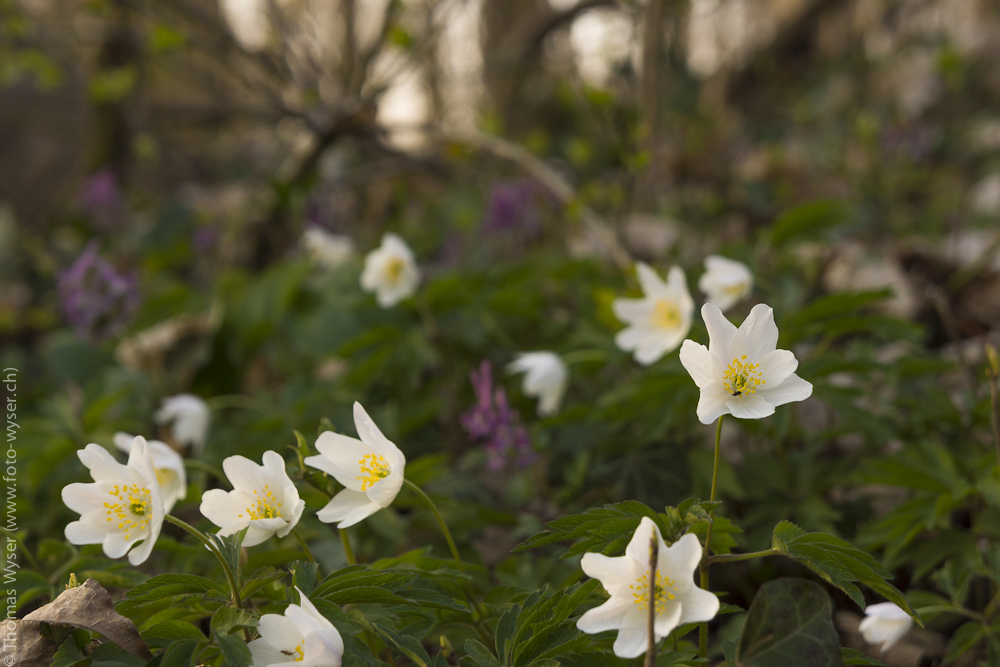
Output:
611 262 694 366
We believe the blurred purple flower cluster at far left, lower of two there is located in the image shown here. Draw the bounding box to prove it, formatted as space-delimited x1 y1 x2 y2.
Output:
59 241 139 341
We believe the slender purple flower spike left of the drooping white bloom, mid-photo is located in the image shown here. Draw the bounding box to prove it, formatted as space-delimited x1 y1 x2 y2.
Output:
460 361 536 471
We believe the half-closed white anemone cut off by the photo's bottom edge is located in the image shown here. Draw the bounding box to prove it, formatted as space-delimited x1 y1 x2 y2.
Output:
249 586 344 667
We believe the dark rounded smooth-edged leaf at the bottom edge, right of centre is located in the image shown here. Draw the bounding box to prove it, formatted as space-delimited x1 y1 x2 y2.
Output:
736 578 844 667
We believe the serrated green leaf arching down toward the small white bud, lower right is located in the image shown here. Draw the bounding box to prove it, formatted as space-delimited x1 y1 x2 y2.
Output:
771 521 923 627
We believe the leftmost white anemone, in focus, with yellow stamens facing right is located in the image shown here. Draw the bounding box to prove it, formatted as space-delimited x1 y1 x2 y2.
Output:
62 436 164 565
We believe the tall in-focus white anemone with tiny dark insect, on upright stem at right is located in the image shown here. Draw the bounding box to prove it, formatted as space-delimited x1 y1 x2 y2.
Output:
680 303 812 424
